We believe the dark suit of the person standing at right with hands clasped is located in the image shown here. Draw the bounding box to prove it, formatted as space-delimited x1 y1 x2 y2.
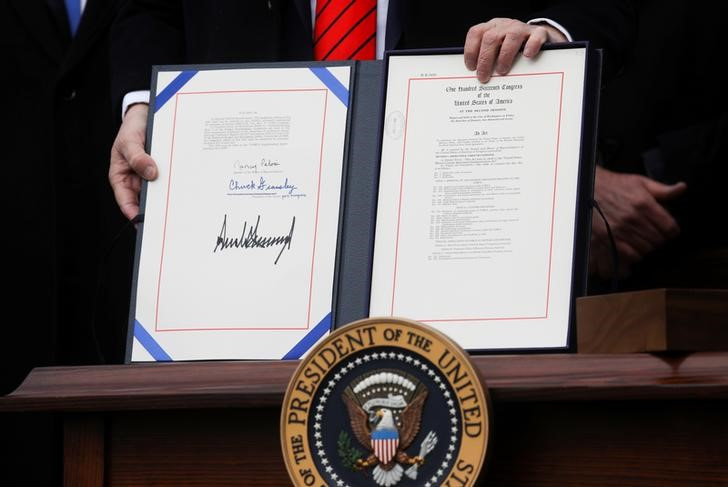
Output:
600 0 728 288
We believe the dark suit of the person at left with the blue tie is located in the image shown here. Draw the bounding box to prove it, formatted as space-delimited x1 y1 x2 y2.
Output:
0 0 128 392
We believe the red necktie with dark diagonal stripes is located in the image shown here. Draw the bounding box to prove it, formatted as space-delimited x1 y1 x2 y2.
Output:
313 0 377 61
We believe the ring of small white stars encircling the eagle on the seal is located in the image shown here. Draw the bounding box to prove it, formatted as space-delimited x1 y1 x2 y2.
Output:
313 352 459 487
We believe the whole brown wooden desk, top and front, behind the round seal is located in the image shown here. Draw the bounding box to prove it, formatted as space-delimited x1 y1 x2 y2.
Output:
0 353 728 487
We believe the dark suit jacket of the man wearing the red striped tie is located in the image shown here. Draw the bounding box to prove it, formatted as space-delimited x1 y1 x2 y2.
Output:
112 0 635 110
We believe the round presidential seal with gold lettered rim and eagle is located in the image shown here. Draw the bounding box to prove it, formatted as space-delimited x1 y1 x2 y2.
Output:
281 318 490 487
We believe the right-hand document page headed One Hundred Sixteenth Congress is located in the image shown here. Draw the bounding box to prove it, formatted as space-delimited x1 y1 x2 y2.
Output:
370 48 586 350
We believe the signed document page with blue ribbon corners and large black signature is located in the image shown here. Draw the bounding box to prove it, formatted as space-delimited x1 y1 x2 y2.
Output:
131 64 352 361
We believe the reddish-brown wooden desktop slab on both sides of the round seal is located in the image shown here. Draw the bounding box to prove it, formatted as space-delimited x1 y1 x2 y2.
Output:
0 352 728 411
